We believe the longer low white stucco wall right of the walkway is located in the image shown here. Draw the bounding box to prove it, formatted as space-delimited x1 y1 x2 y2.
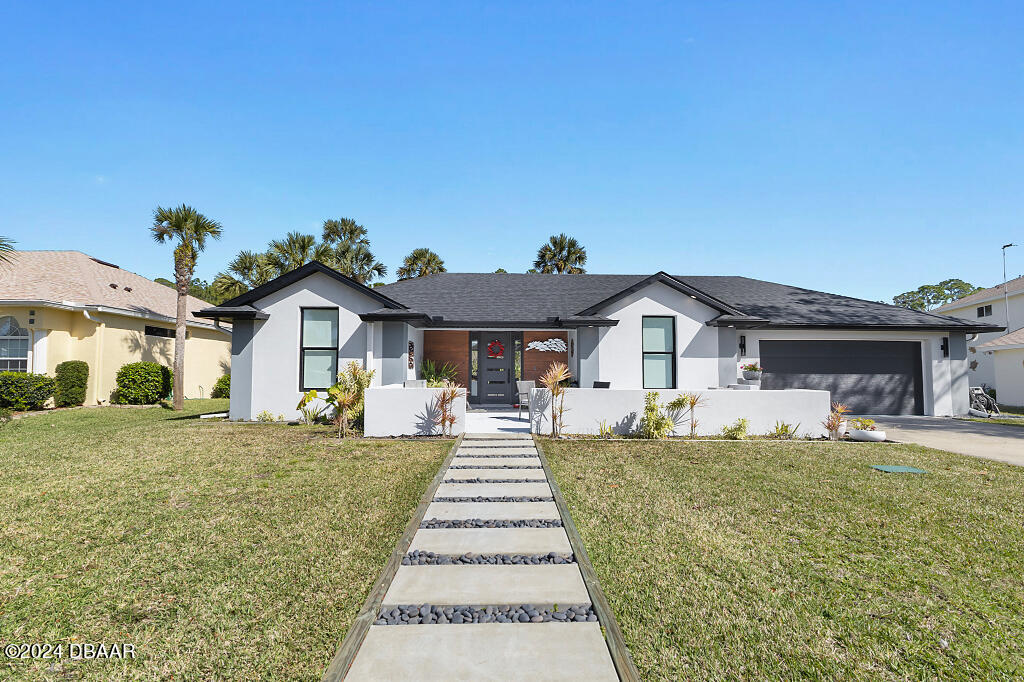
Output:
529 388 829 437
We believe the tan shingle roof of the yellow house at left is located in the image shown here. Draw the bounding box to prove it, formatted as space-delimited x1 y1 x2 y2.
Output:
0 251 222 327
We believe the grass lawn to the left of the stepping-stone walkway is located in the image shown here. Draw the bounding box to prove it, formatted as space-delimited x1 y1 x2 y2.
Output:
0 400 451 680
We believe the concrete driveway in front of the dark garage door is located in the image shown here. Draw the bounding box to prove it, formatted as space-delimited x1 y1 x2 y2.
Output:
876 417 1024 466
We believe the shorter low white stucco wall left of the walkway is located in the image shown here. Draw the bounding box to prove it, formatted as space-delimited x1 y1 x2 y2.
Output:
362 385 466 436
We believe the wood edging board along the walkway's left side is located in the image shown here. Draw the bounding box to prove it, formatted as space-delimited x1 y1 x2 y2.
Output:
323 434 465 682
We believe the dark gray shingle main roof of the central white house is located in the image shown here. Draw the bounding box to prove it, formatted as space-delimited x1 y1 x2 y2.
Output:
376 272 995 331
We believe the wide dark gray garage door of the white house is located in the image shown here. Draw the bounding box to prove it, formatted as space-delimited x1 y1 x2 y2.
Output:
760 341 925 415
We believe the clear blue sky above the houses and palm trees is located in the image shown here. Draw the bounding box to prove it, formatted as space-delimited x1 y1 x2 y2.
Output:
0 1 1024 300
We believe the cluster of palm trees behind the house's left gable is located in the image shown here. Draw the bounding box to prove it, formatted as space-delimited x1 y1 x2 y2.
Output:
210 218 387 294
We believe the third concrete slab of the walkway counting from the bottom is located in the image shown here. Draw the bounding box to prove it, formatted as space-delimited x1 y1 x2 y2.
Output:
409 528 572 556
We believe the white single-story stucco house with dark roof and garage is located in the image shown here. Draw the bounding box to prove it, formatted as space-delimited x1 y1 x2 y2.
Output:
198 262 998 428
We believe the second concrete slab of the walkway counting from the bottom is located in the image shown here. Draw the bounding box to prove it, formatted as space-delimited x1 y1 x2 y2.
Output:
383 563 590 602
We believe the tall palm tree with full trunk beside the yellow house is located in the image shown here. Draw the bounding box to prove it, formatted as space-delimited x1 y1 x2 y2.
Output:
151 204 222 410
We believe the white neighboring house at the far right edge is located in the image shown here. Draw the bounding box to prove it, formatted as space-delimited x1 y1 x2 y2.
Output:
935 276 1024 406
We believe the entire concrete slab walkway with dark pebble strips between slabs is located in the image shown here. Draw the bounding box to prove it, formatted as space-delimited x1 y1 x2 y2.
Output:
345 433 618 681
